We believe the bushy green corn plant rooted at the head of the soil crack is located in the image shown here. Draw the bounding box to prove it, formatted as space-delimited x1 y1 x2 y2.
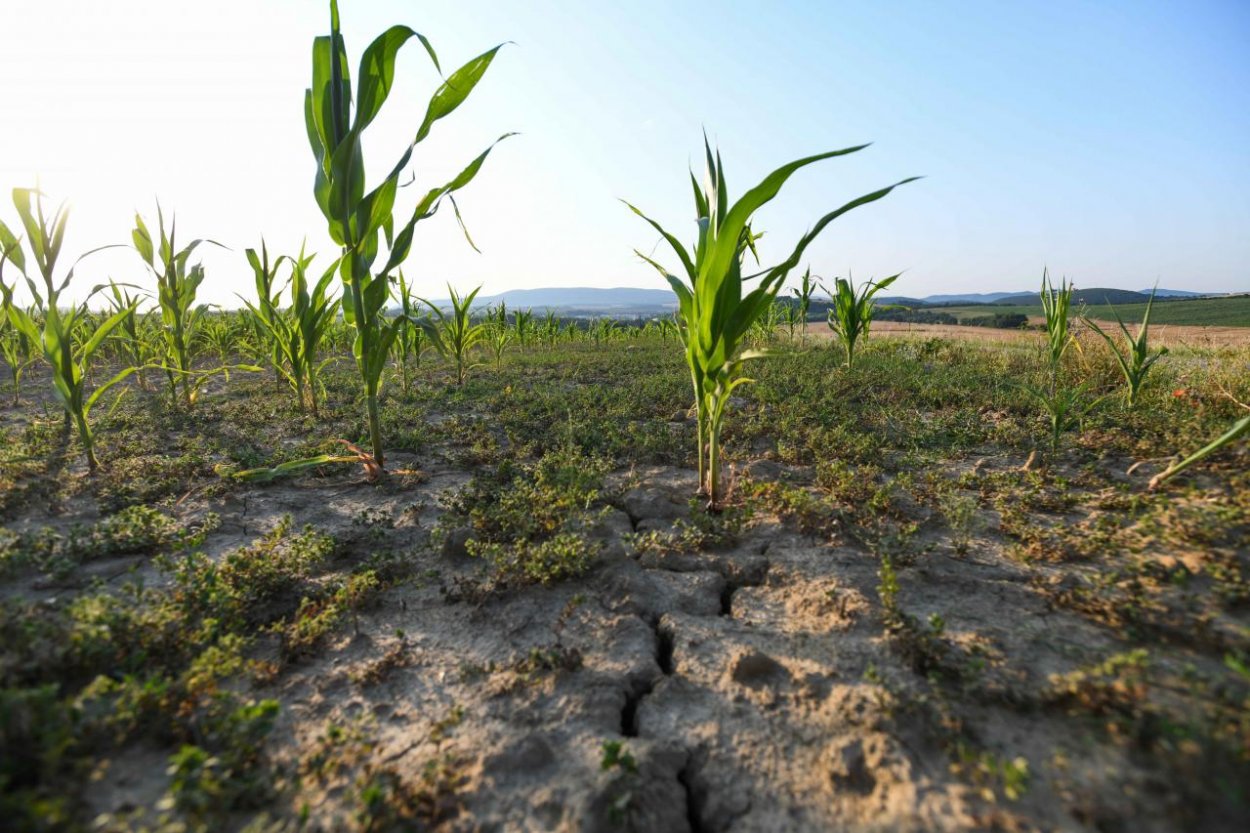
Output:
626 138 911 509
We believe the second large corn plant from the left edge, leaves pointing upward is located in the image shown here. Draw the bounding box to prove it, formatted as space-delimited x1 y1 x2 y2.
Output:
131 205 235 408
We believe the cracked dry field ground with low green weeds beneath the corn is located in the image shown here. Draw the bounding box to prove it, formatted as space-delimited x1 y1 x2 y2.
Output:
0 331 1250 830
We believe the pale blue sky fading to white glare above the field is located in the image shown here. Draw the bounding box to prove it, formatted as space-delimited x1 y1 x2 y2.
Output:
0 0 1250 305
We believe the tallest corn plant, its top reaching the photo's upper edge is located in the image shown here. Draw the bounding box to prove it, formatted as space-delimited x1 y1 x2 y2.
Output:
304 0 510 467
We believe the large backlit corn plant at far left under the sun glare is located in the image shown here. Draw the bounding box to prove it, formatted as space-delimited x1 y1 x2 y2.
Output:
0 188 135 473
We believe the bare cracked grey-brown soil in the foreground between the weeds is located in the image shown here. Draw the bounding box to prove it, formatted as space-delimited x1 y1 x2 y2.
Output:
63 459 1235 832
